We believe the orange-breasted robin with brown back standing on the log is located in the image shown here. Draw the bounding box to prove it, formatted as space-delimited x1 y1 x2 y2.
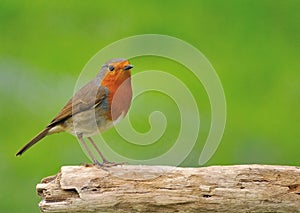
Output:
16 58 133 165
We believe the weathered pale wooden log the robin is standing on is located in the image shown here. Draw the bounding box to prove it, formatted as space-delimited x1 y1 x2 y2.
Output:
37 165 300 212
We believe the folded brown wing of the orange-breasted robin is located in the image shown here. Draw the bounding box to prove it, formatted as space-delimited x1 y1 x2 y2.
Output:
48 80 108 127
